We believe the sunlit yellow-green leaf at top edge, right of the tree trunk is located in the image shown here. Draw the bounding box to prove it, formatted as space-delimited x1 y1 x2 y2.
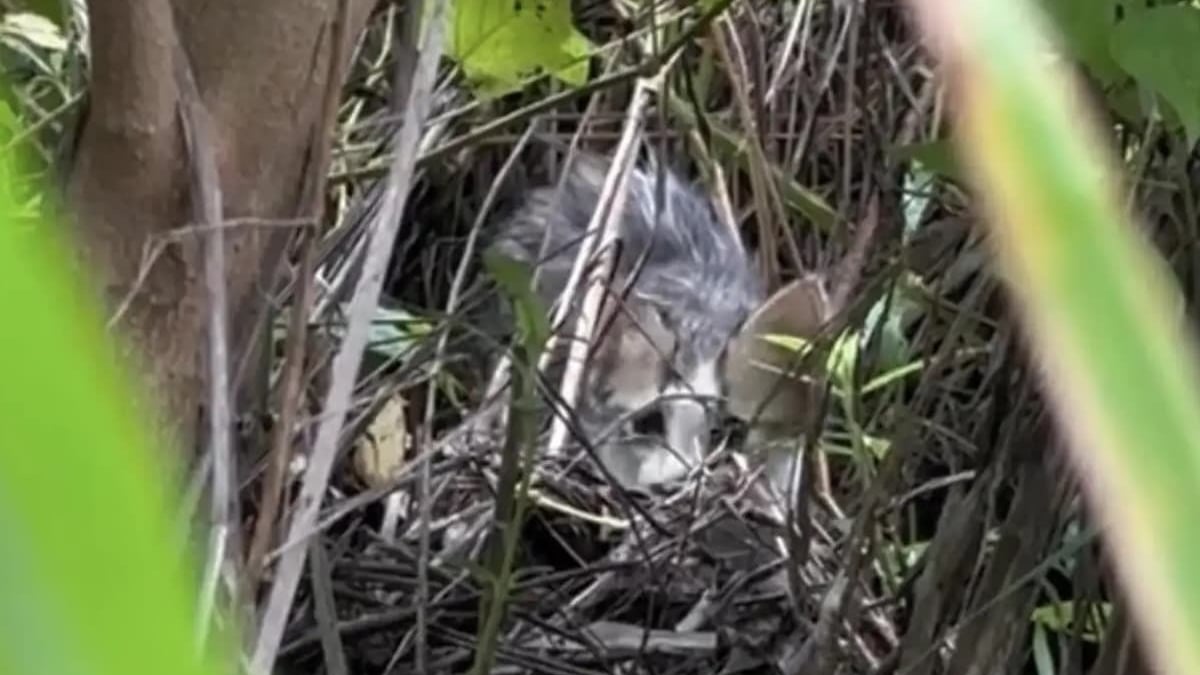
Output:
446 0 593 96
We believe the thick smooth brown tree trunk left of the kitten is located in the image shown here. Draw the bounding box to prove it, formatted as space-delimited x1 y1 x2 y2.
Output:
67 0 374 454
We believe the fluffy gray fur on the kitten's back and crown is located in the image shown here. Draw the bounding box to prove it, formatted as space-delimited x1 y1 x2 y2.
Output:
494 155 762 366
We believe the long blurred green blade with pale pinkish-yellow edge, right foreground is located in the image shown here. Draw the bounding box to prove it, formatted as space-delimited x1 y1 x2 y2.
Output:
913 0 1200 673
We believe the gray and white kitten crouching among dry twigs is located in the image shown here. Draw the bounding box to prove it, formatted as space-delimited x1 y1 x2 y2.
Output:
482 151 827 485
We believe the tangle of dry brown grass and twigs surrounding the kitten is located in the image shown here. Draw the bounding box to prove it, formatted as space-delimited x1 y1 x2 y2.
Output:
11 0 1200 675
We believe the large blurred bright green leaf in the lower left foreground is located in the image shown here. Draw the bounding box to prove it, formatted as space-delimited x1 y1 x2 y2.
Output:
0 97 220 675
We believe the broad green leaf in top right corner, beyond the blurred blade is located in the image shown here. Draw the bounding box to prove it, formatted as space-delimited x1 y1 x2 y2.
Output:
1111 5 1200 144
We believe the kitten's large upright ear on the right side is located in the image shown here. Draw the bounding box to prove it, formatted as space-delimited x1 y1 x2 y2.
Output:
725 276 829 423
